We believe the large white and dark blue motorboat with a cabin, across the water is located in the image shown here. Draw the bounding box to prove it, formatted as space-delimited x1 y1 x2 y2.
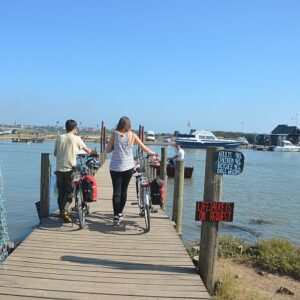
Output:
175 129 242 149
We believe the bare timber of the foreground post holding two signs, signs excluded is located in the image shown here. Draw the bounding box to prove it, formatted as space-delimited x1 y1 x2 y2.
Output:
198 147 223 294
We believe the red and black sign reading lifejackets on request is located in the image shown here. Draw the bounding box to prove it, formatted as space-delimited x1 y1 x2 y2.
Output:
195 201 234 222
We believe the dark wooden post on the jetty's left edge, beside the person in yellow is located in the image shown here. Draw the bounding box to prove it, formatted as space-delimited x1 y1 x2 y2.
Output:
39 153 50 220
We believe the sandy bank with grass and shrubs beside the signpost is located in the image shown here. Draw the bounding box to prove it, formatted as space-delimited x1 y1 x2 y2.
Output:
187 236 300 300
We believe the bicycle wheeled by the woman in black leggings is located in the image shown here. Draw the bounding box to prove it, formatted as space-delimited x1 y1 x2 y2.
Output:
135 158 151 232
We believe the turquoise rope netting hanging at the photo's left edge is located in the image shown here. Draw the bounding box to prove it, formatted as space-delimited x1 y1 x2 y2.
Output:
0 165 9 263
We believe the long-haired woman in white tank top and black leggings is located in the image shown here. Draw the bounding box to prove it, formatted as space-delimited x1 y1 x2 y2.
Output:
106 116 156 226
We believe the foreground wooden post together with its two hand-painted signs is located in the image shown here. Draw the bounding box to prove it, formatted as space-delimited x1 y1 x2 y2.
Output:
195 147 244 294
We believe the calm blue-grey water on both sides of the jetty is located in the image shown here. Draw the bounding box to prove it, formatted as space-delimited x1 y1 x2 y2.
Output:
0 141 300 245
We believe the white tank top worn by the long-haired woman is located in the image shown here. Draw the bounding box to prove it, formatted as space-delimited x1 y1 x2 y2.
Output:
109 131 134 172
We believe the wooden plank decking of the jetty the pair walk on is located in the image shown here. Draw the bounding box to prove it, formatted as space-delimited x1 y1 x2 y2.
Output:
0 161 210 300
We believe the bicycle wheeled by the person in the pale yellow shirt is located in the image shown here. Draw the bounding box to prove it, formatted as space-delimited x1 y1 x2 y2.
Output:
72 154 100 229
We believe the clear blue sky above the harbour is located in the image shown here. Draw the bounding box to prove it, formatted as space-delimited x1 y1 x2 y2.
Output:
0 0 300 133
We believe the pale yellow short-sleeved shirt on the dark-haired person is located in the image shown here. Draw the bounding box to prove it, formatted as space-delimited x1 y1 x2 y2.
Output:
54 133 86 172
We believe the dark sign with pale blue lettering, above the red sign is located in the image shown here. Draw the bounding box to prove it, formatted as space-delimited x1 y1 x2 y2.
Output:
214 150 244 175
